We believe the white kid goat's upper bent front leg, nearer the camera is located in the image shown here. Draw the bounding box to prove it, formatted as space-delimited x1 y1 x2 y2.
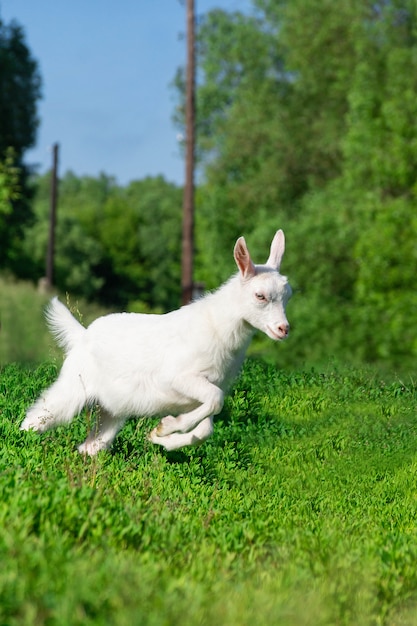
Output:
153 375 224 436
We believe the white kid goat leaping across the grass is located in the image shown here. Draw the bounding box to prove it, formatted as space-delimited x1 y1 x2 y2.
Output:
21 230 291 455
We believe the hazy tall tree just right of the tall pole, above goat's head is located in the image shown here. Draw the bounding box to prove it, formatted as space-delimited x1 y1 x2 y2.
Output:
176 0 366 286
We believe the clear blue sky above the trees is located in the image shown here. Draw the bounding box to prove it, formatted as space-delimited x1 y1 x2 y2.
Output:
0 0 250 185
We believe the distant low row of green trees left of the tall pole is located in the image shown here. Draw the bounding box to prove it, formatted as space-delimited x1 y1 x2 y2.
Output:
24 172 182 310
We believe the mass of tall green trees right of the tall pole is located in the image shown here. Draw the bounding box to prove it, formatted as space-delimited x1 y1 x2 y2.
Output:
188 0 417 368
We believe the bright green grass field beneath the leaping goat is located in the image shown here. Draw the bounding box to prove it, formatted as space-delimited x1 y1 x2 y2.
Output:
0 360 417 626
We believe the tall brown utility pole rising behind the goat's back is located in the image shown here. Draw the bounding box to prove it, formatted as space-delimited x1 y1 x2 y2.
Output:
181 0 195 304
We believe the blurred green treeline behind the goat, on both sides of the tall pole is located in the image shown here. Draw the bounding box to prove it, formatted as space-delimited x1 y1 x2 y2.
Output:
3 0 417 368
